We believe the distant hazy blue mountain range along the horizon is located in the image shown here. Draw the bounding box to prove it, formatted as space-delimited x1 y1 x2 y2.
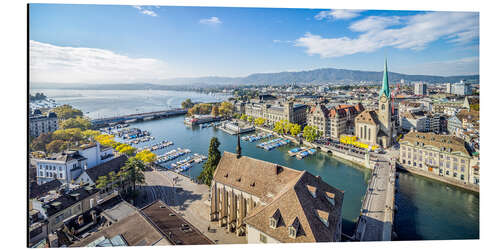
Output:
32 68 479 89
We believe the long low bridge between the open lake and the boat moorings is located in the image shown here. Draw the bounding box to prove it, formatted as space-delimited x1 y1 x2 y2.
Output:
91 108 187 128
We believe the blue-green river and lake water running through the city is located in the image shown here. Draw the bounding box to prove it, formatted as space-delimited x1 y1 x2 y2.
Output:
32 89 479 240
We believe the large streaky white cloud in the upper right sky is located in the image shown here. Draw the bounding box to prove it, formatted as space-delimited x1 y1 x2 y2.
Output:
295 12 479 58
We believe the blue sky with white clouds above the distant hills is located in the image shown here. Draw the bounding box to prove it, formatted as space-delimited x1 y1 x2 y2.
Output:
29 4 479 83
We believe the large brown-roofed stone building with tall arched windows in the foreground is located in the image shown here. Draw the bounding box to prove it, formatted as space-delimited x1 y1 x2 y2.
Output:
210 146 344 243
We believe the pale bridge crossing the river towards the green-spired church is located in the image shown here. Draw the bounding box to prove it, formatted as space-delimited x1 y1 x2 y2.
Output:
354 158 396 241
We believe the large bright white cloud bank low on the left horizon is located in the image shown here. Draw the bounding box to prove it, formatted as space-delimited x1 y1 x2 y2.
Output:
29 40 172 83
